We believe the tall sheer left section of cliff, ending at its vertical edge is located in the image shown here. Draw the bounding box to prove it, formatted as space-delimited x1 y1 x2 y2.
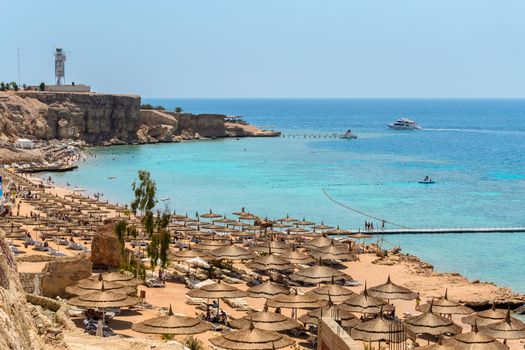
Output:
0 91 140 144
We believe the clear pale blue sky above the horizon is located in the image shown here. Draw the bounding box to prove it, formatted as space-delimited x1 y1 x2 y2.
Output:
0 0 525 98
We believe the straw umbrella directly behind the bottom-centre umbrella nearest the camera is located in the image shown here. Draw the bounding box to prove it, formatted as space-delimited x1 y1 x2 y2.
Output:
230 306 301 332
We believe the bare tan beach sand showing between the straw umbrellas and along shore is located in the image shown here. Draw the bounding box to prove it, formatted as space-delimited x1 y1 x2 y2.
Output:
2 169 525 350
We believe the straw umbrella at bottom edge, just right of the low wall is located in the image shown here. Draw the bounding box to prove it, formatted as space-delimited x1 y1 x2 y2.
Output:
350 312 407 348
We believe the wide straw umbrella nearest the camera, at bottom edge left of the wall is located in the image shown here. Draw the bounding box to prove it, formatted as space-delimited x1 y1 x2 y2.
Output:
210 323 295 350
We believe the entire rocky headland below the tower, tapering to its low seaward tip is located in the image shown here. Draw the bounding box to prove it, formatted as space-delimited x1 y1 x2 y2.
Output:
0 91 278 145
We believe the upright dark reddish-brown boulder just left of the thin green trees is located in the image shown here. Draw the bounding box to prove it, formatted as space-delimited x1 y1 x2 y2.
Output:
91 224 121 268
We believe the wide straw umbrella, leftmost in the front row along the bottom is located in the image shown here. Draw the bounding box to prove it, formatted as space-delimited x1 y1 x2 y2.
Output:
131 305 212 335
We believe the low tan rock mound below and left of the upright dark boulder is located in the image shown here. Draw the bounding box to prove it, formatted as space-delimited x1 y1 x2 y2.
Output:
40 254 92 298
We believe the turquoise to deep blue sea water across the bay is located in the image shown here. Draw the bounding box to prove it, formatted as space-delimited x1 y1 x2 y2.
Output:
42 99 525 292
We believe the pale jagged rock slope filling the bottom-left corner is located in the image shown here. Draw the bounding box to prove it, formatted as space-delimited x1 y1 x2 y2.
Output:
0 237 45 350
